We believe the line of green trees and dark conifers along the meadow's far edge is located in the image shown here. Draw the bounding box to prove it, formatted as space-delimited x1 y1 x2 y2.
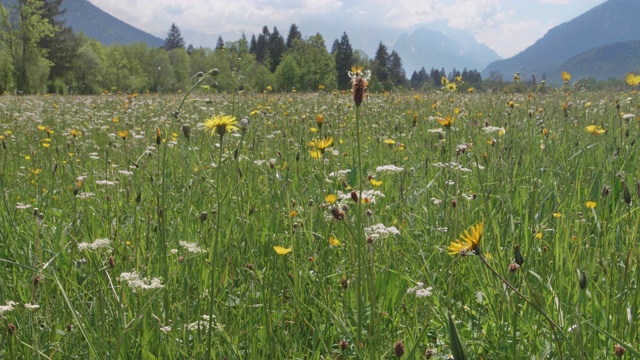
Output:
0 0 482 94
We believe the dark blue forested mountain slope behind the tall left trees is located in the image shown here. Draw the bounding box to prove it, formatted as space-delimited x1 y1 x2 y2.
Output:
0 0 164 47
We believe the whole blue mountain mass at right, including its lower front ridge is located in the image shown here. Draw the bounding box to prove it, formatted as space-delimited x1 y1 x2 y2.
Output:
481 0 640 83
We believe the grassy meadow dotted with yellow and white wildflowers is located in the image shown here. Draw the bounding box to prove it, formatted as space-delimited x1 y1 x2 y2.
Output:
0 77 640 359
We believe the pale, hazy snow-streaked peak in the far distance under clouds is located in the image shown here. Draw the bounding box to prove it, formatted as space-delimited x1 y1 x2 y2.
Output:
393 27 500 76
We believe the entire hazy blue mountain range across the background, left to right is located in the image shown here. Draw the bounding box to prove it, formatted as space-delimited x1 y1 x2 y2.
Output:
0 0 640 83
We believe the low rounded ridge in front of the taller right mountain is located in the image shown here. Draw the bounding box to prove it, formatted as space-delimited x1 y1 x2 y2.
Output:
560 40 640 80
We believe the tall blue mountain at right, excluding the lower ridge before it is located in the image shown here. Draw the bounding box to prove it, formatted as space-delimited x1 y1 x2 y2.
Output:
482 0 640 82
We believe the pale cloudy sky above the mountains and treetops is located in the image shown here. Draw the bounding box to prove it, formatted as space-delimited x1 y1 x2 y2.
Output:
89 0 605 57
